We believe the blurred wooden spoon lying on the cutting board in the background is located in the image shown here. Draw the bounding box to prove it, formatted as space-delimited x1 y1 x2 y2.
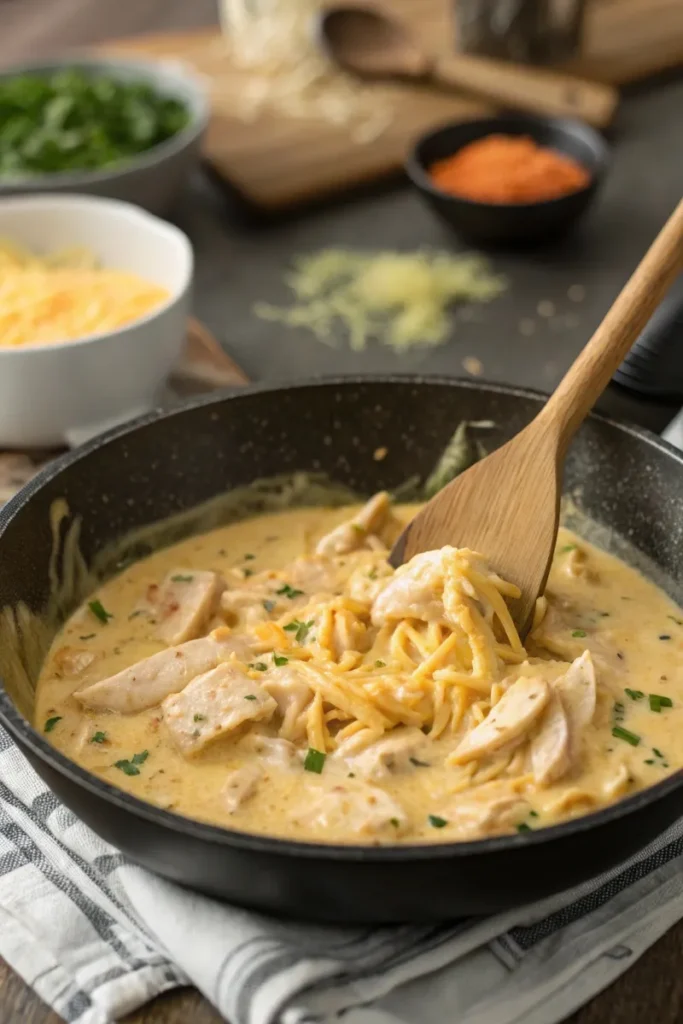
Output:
317 4 618 128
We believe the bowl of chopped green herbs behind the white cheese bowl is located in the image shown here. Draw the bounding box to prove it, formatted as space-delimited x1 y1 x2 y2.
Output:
0 58 209 213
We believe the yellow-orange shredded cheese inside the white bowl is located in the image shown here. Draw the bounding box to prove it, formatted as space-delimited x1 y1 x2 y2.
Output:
0 241 168 348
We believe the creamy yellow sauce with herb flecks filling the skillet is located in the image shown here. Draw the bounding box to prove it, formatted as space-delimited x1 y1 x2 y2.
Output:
35 506 683 843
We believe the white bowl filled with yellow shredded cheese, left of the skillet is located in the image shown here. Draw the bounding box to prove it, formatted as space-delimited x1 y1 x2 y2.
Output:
0 195 194 447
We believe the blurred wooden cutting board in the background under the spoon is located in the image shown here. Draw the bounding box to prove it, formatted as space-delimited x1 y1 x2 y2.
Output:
100 0 683 210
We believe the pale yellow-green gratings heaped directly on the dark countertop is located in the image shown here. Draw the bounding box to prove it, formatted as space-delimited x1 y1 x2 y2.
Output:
254 249 506 351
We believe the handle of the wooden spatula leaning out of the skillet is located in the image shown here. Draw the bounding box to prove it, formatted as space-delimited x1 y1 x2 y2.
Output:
538 200 683 451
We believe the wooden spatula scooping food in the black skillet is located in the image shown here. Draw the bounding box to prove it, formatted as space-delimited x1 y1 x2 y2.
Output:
390 200 683 634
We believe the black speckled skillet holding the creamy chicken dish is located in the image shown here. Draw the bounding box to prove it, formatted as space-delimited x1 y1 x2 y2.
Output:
0 378 683 922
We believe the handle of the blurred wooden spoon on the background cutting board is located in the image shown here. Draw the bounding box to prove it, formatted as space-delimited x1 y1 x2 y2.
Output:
432 54 618 128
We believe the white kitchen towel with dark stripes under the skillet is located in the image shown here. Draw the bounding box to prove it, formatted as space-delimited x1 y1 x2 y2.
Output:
0 729 683 1024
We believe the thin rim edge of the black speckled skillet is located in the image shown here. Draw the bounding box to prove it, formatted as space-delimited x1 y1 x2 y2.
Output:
0 374 683 863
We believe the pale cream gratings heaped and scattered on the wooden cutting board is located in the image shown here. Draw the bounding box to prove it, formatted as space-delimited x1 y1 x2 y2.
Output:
215 0 393 143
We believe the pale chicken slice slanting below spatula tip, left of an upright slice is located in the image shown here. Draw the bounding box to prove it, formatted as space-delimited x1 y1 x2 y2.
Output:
452 677 550 764
